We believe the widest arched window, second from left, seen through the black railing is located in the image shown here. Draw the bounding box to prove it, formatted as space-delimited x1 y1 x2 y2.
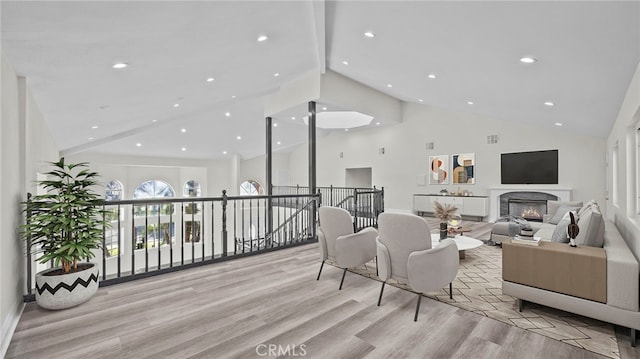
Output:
133 180 175 249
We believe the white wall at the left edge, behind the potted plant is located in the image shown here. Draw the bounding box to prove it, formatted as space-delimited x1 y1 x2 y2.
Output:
0 54 58 355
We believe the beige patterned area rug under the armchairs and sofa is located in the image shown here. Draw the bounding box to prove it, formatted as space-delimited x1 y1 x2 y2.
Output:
340 221 620 358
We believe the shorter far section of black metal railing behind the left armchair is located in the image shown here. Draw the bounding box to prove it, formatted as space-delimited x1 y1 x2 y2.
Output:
272 185 384 231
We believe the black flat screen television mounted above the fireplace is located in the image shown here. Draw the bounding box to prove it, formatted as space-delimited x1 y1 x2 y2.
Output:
500 150 558 184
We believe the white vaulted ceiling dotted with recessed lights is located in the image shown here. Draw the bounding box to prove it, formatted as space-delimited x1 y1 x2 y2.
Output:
1 1 640 159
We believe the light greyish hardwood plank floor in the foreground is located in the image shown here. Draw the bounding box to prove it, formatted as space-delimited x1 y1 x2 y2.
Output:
7 244 638 358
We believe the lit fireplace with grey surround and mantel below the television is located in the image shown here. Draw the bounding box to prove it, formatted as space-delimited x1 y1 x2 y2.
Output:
499 191 558 222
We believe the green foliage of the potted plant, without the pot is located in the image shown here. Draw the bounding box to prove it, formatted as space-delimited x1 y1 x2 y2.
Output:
22 157 108 273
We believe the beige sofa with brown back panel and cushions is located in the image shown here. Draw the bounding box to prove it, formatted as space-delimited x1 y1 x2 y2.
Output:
502 215 640 346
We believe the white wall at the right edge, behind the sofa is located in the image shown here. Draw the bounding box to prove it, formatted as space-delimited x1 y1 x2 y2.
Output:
606 63 640 260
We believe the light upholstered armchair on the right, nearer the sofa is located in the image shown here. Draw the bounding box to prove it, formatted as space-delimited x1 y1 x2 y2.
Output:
376 213 460 321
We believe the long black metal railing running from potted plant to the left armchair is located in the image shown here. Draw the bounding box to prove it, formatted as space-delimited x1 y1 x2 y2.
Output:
25 191 319 300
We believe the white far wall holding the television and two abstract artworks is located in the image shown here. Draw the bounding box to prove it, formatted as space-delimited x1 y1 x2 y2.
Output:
290 103 605 214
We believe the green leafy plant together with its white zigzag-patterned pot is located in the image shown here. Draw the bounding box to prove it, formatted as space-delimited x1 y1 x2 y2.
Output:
22 157 108 309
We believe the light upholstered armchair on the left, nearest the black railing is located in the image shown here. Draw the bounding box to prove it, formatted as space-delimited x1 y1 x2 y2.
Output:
316 207 378 290
